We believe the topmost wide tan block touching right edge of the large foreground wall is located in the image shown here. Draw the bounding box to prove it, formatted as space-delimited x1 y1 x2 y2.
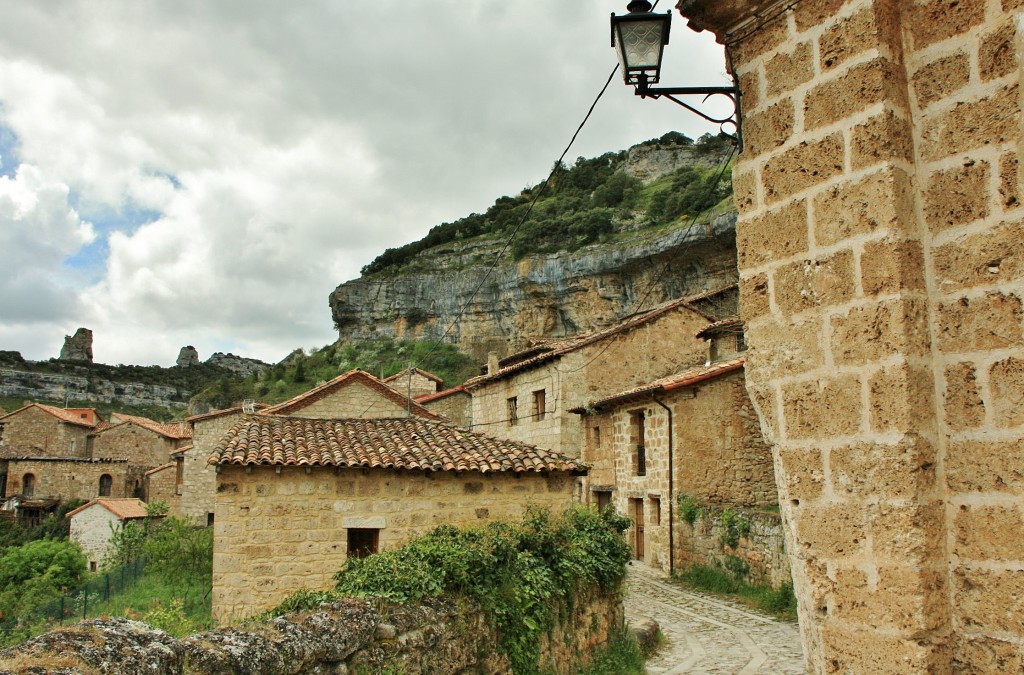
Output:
921 83 1020 162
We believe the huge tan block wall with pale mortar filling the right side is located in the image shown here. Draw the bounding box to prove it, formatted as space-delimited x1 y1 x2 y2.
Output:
681 0 1024 673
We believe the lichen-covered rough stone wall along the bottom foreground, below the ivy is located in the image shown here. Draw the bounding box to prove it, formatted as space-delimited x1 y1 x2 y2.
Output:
0 589 624 675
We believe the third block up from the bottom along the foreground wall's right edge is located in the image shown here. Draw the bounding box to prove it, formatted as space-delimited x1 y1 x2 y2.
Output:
953 504 1024 562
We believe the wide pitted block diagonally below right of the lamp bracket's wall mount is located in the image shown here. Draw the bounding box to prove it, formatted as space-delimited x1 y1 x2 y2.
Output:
761 133 846 204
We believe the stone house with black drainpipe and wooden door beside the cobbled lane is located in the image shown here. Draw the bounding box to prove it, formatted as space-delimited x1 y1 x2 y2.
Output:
569 319 788 583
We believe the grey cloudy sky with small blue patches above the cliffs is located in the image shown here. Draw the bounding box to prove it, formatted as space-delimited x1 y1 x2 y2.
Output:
0 0 728 366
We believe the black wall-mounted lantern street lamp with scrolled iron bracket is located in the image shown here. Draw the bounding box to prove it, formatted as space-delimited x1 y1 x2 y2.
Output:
611 0 742 146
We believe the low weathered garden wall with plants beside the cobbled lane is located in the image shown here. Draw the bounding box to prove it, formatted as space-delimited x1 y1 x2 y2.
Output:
676 504 793 588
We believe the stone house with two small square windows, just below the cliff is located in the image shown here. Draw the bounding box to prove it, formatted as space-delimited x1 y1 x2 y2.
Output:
465 285 736 456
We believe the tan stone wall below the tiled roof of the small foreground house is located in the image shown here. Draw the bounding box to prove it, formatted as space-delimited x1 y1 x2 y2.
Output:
213 465 575 623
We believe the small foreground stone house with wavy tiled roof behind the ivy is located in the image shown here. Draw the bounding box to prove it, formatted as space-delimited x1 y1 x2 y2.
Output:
209 413 584 623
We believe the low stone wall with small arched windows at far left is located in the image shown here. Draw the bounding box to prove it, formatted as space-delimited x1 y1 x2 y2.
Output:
7 459 134 501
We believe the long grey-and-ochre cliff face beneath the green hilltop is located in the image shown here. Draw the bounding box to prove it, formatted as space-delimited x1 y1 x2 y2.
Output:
330 213 737 362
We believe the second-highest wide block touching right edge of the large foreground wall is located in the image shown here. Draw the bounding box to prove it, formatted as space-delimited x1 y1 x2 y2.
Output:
933 220 1024 293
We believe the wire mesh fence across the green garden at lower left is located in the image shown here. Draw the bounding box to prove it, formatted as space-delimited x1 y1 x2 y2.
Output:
0 557 145 644
